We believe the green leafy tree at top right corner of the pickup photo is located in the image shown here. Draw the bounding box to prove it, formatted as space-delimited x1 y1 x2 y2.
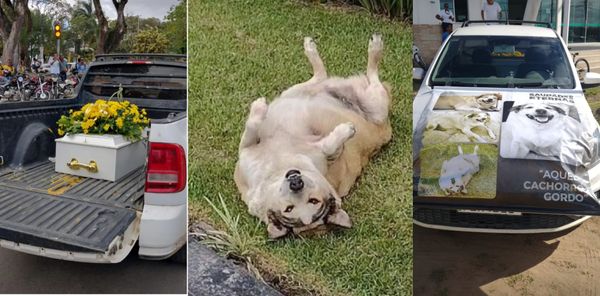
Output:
165 0 187 54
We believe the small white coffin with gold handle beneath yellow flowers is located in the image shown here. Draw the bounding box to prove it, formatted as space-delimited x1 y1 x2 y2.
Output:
55 134 147 181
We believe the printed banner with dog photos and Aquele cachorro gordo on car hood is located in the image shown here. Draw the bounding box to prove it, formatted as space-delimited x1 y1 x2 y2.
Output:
413 90 600 215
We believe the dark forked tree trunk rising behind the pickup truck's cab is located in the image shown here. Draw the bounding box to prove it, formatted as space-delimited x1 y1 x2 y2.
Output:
93 0 128 54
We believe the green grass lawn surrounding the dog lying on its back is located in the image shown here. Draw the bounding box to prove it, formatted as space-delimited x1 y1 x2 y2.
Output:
189 0 412 295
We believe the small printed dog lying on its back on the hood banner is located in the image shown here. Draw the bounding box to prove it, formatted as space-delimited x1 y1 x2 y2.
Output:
439 145 479 195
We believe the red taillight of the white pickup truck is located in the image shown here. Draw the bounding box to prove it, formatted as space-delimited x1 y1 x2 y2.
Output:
146 143 187 193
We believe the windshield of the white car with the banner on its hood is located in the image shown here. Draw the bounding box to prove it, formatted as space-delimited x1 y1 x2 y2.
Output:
429 36 575 89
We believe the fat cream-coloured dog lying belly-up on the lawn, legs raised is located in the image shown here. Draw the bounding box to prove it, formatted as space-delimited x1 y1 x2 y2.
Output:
235 35 391 238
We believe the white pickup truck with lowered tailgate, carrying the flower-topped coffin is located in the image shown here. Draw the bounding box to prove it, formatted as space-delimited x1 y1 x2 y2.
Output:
0 54 187 263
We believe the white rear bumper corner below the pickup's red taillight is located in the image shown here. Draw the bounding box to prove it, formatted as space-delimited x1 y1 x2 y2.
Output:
139 204 187 260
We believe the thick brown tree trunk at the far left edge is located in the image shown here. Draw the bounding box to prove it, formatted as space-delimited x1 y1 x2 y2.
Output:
0 0 31 66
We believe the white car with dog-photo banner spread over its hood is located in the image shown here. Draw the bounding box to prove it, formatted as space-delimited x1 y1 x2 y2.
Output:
413 22 600 233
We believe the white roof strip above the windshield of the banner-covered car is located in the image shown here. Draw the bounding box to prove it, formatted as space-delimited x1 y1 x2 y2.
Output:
454 24 558 38
